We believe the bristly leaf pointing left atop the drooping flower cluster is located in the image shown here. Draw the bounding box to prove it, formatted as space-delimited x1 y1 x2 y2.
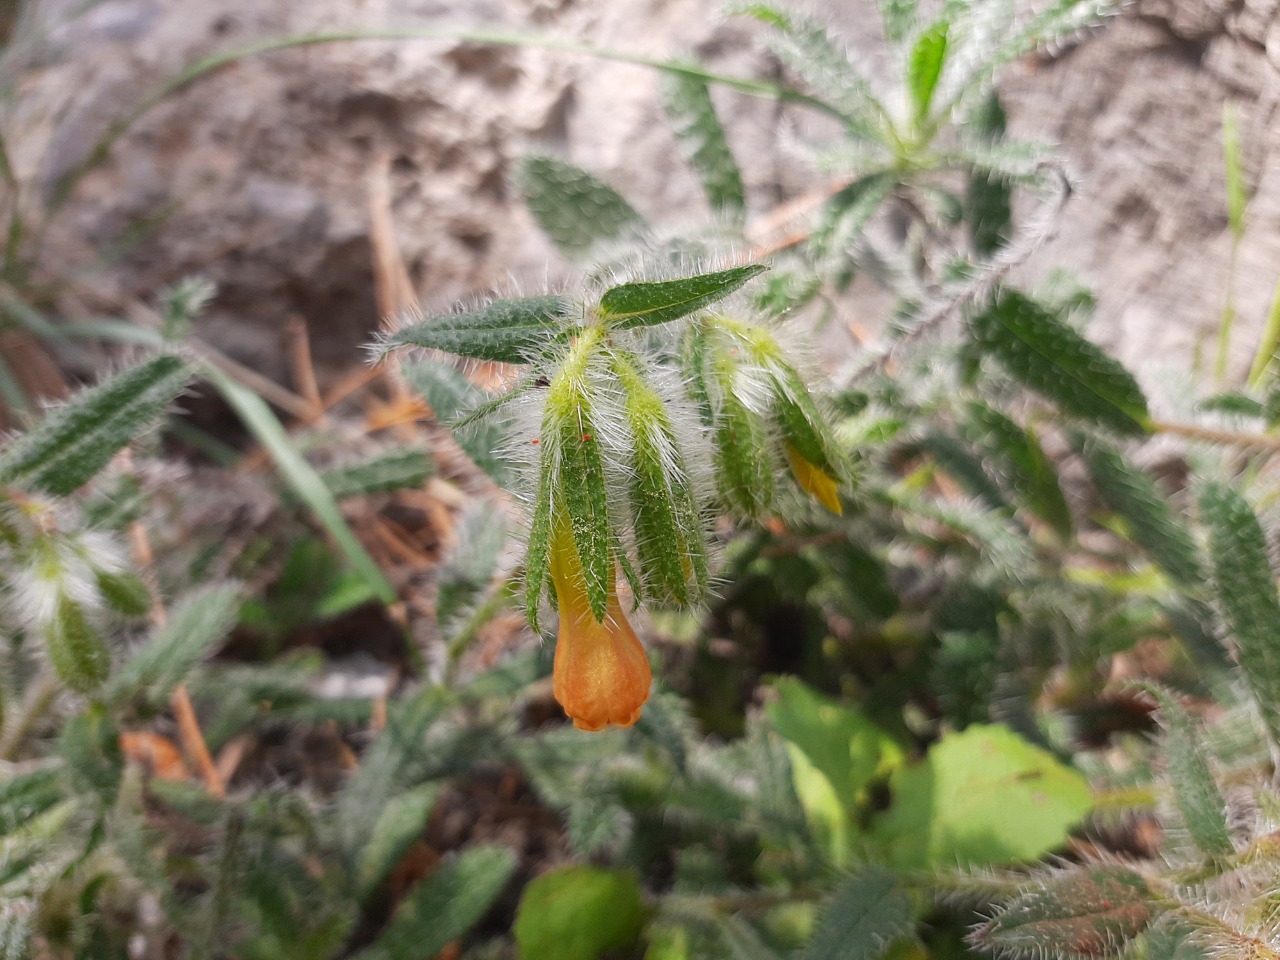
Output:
381 294 573 364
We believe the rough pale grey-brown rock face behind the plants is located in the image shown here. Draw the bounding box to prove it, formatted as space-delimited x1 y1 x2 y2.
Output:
0 0 1280 399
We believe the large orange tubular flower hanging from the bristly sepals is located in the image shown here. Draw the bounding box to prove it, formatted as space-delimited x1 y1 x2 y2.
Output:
550 518 653 731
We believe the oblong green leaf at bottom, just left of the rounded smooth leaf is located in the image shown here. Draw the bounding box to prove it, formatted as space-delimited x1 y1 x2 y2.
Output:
356 846 516 960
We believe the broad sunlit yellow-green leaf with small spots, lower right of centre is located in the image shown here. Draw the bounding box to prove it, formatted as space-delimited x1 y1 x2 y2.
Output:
872 724 1092 870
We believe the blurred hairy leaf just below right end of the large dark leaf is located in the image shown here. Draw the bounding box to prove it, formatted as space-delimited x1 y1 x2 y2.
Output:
1080 439 1204 586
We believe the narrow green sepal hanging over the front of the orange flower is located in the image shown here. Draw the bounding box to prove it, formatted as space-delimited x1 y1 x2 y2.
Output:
558 404 616 623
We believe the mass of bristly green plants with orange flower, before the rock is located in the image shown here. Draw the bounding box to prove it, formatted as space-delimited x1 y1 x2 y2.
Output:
17 0 1280 960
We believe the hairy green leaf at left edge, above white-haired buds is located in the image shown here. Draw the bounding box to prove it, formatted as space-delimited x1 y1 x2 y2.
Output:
0 353 191 497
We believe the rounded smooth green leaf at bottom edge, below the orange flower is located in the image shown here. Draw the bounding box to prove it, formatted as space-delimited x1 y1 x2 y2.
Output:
512 867 644 960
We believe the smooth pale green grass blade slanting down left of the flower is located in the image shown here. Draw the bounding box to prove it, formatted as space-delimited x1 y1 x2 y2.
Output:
204 367 397 604
